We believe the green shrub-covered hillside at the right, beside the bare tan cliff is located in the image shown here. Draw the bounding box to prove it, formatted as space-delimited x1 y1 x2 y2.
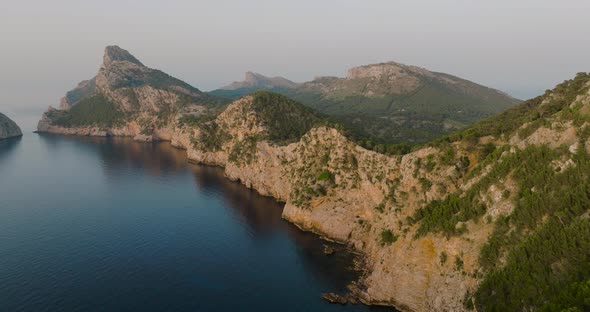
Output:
413 74 590 311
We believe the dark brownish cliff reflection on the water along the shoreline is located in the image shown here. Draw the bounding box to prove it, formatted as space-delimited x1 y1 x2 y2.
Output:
33 134 392 311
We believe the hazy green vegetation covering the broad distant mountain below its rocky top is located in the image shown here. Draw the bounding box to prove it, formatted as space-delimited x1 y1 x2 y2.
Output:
211 68 518 144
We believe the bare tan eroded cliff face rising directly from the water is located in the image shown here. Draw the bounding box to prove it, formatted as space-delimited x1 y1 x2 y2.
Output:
35 92 504 311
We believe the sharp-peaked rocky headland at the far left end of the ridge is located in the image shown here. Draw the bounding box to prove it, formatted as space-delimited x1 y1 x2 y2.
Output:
38 46 225 139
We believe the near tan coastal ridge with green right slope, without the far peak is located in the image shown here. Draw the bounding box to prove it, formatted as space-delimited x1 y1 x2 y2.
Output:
40 47 590 311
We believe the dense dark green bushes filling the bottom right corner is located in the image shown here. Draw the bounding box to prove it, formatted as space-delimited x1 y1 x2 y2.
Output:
475 217 590 311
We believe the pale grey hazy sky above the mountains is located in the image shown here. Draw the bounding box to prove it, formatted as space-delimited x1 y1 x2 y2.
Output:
0 0 590 127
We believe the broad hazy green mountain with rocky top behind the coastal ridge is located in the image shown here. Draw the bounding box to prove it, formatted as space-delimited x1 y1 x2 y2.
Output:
211 62 519 147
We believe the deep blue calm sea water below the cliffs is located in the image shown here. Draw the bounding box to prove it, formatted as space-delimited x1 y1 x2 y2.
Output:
0 133 398 312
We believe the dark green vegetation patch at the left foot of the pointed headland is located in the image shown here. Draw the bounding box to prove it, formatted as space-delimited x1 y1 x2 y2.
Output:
47 94 125 127
